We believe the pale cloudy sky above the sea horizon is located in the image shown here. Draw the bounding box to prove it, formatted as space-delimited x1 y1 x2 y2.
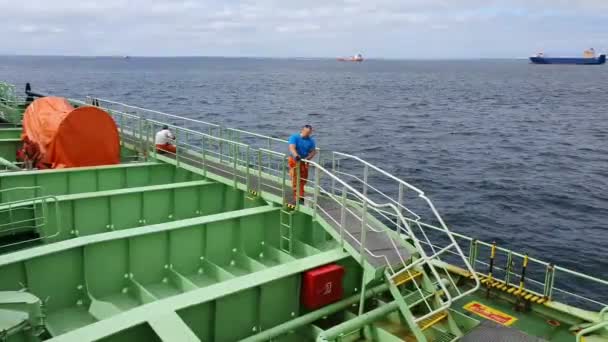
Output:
0 0 608 59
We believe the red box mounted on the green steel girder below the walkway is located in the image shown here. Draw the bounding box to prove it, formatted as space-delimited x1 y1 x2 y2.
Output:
302 264 344 310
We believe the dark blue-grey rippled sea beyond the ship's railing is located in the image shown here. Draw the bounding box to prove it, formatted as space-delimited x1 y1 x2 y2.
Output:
0 57 608 302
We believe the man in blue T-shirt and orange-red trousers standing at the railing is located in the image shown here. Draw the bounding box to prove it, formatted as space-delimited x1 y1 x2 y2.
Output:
288 125 317 203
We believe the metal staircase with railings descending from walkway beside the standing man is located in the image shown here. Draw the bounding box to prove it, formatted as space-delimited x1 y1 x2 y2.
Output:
296 162 476 341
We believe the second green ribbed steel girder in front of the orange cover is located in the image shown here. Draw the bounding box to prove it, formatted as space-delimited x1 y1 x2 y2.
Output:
0 180 262 246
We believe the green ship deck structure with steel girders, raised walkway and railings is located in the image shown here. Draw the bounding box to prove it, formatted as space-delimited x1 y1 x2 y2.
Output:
0 84 608 342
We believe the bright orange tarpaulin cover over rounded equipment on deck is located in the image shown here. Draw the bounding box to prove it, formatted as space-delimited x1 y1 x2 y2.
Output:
21 97 120 168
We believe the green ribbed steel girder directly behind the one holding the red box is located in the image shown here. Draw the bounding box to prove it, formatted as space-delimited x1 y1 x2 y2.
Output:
0 207 342 335
